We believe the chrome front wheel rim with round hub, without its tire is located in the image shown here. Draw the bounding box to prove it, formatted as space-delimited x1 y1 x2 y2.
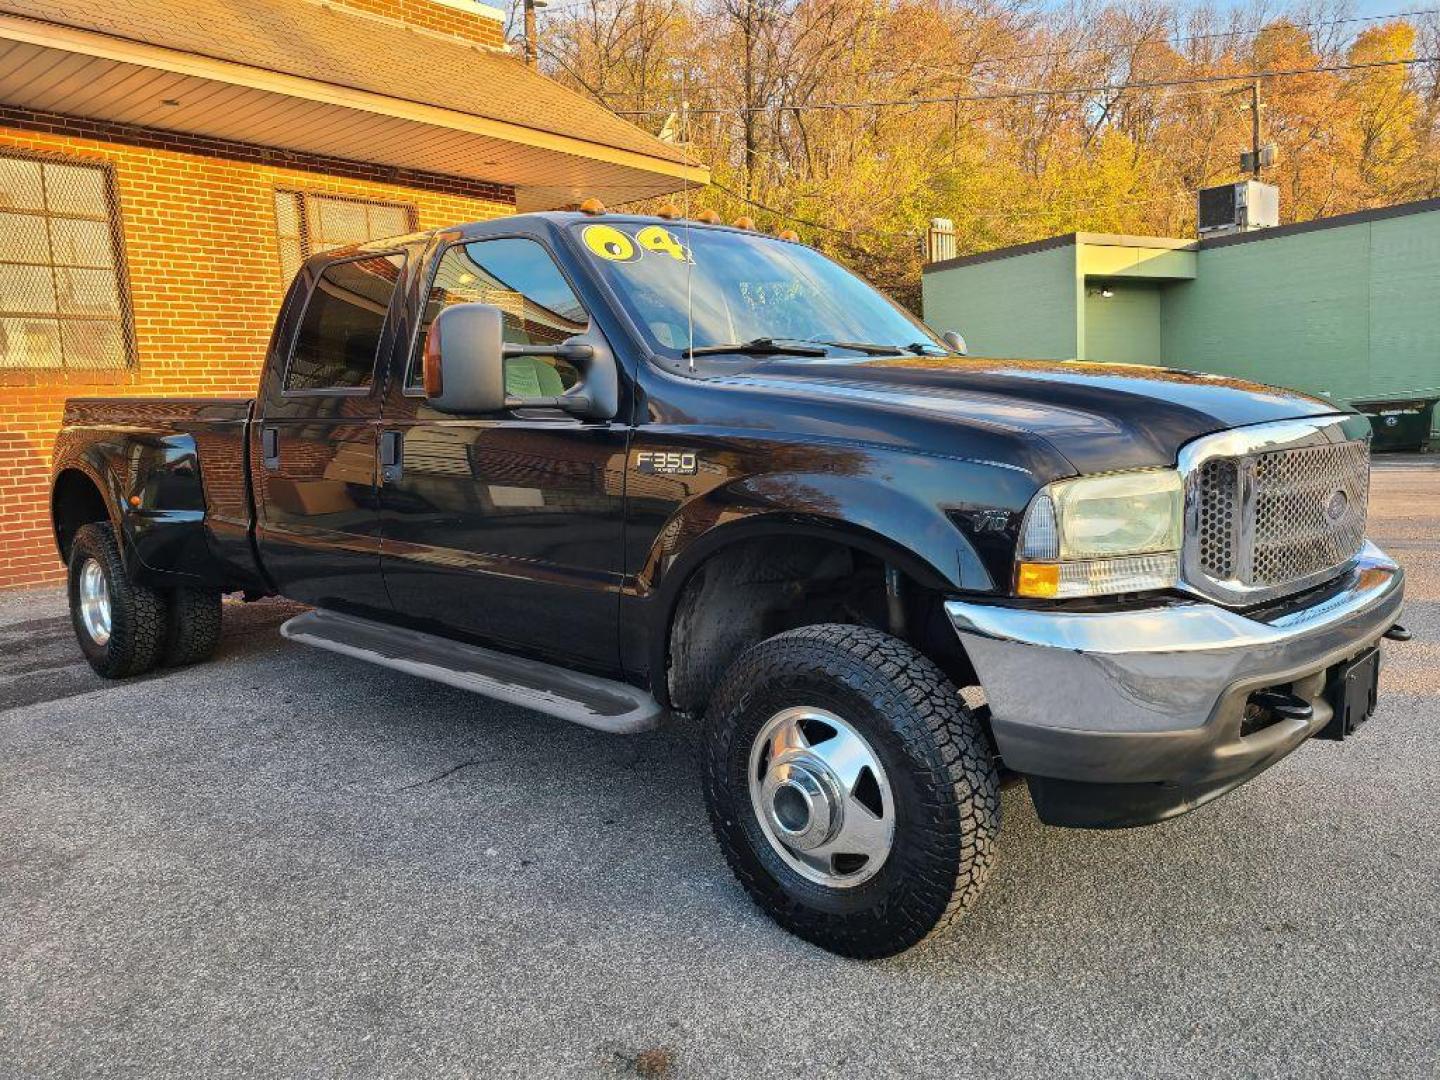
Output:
750 707 894 888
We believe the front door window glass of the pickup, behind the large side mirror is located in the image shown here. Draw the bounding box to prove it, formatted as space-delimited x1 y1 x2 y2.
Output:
405 238 590 397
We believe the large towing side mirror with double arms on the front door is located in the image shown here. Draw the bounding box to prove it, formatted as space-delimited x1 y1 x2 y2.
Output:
422 304 619 419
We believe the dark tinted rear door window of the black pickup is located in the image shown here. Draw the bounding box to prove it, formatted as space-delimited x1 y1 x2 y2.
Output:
285 255 405 393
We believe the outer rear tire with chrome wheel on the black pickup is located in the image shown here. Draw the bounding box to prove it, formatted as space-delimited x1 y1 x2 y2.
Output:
69 524 166 678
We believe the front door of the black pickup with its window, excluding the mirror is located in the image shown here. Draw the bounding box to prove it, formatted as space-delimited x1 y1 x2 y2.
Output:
380 235 628 671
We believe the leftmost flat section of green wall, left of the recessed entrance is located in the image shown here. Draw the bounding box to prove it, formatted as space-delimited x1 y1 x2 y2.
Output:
922 243 1080 360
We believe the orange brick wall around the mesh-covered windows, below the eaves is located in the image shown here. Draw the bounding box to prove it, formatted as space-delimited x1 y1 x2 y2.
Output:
0 110 514 588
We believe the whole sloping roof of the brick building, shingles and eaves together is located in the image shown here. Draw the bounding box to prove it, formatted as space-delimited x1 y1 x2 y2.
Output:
0 0 708 210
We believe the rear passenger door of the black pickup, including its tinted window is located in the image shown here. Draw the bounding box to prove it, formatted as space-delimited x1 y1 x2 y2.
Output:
251 252 405 612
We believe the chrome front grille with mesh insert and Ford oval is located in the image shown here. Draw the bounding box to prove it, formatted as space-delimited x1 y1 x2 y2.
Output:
1185 436 1369 600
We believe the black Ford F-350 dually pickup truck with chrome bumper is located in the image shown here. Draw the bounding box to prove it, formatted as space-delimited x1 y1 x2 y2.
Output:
53 213 1405 956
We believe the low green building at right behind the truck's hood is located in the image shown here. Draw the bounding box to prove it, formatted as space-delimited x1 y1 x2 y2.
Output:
923 199 1440 443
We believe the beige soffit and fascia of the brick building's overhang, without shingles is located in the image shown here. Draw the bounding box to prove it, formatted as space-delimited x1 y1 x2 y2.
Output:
0 14 710 210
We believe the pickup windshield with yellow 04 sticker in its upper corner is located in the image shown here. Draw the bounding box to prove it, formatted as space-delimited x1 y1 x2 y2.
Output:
573 222 949 361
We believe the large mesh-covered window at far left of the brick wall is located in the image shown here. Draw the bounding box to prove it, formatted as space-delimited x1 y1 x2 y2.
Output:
0 153 131 372
